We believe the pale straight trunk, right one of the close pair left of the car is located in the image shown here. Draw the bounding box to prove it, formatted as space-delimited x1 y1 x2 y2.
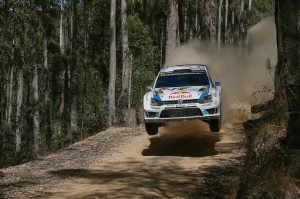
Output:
121 0 129 98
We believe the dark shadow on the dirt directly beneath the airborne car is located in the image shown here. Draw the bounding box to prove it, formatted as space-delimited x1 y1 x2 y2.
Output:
142 120 221 157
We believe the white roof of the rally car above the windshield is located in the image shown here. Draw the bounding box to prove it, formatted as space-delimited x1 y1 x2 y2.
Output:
160 64 208 73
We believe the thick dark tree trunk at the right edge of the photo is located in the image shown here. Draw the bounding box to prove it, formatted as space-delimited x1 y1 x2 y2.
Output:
275 0 300 149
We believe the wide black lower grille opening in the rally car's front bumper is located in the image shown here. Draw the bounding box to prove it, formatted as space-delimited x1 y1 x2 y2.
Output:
160 108 203 118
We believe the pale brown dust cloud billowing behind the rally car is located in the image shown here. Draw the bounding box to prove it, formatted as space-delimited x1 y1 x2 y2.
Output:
166 17 277 120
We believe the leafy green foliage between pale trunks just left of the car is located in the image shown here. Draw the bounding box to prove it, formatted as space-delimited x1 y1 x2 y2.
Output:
126 15 159 109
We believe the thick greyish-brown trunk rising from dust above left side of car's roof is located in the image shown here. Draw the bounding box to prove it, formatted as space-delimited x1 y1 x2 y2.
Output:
166 0 177 60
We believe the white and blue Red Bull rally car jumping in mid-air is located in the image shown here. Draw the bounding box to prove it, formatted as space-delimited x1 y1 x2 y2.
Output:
144 64 221 135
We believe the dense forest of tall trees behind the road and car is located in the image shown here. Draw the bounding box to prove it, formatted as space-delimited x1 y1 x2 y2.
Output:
0 0 299 173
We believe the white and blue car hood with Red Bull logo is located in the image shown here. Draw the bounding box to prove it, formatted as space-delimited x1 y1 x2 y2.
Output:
153 86 210 101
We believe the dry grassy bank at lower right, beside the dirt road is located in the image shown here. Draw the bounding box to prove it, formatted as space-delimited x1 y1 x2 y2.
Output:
238 105 300 198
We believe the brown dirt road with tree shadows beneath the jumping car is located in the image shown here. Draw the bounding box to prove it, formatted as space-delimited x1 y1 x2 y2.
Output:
0 121 245 199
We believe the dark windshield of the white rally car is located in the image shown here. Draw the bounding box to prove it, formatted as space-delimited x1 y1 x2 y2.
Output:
155 73 209 88
